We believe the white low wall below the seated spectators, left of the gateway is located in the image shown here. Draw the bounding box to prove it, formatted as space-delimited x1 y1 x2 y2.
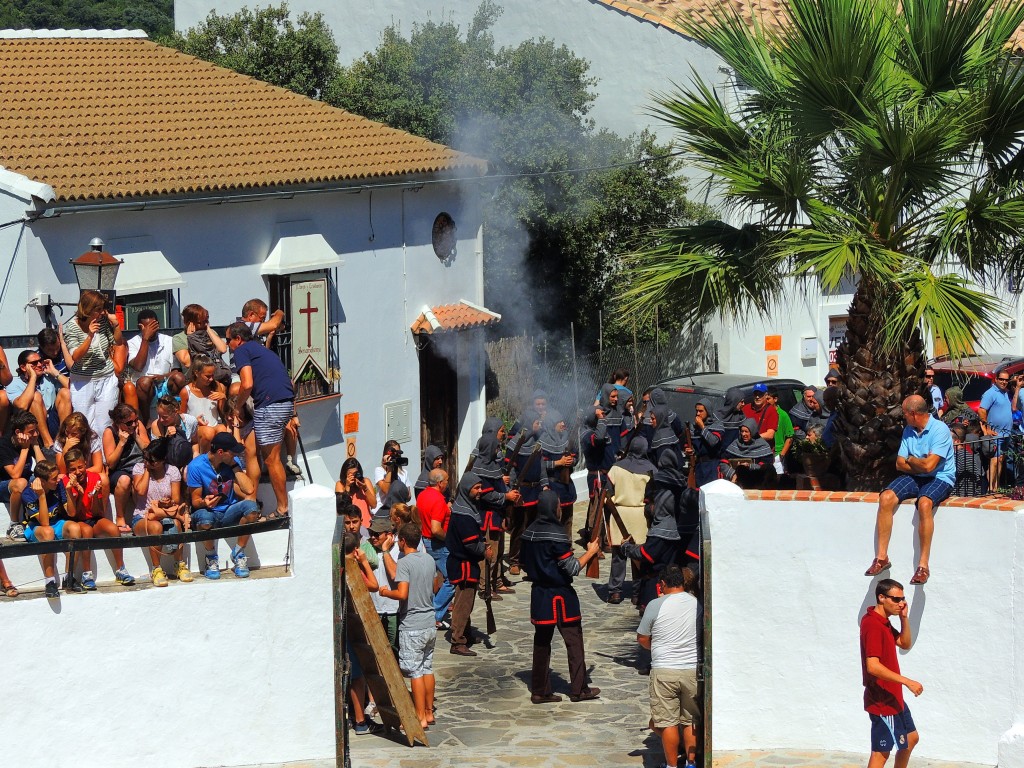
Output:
0 485 336 768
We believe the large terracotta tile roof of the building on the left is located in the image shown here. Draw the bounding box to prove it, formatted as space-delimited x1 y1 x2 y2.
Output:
0 33 486 202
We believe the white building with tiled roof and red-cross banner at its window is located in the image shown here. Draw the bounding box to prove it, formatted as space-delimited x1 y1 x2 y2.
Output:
0 32 498 483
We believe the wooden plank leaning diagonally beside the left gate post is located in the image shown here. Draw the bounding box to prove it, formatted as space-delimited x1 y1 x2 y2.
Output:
345 555 430 746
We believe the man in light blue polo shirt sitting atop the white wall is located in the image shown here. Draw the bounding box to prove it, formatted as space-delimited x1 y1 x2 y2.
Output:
864 394 956 585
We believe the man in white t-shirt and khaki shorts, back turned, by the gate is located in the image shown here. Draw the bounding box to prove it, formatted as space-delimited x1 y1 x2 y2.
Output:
637 565 700 768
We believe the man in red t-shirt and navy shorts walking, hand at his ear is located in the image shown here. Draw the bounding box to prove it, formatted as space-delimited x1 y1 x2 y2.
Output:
860 579 924 768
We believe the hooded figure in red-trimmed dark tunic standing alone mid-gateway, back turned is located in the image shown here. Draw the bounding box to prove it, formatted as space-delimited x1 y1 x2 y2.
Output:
522 489 600 705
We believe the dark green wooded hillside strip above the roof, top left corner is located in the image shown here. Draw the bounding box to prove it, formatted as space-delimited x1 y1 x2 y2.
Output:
0 0 174 37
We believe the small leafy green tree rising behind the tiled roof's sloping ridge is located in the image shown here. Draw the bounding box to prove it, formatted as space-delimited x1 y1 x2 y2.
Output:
161 3 339 98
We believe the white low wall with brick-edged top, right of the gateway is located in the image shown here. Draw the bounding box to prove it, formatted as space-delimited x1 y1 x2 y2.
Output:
702 481 1024 768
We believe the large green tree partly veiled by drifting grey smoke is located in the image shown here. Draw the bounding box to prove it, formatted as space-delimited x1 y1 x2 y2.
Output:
325 0 696 342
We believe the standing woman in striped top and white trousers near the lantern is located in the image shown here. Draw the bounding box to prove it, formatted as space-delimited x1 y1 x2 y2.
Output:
61 291 124 433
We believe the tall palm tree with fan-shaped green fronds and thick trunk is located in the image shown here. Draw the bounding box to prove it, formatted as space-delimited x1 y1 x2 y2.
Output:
621 0 1024 489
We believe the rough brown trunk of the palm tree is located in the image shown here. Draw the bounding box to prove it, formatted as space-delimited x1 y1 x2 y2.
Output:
836 280 925 492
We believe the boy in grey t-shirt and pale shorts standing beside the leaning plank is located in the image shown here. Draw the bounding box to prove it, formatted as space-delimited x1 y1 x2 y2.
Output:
381 522 437 728
